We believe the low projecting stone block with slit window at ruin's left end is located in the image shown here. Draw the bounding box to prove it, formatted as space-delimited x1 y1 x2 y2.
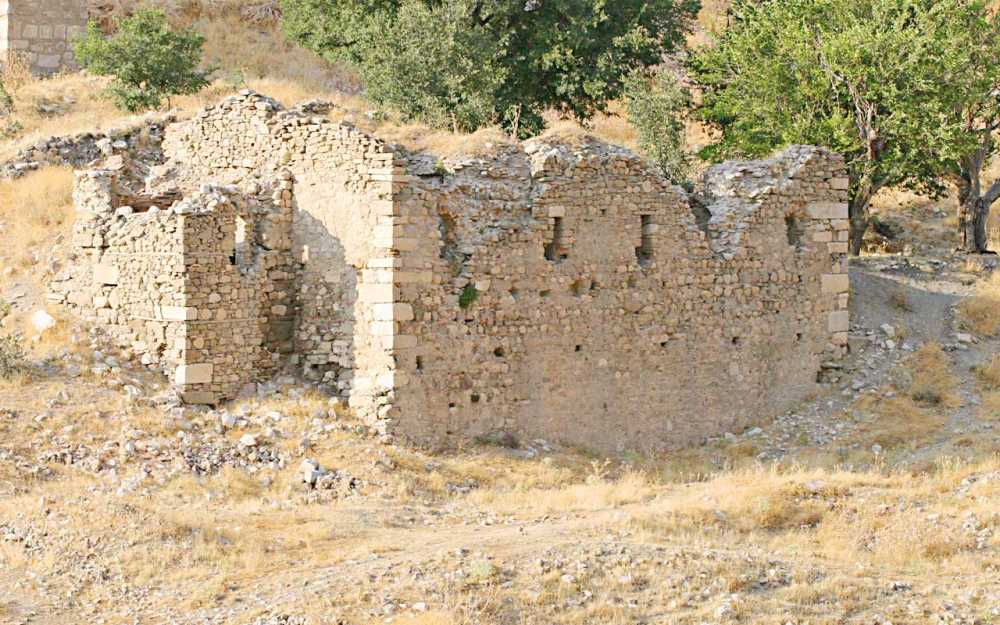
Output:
50 170 280 403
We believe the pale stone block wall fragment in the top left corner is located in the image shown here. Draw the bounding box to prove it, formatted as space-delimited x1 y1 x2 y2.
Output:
0 0 88 74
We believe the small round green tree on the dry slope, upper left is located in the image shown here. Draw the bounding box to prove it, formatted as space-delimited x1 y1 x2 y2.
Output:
74 9 211 112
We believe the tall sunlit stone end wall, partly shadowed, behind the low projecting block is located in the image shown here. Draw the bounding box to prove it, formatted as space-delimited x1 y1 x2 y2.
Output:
156 92 402 414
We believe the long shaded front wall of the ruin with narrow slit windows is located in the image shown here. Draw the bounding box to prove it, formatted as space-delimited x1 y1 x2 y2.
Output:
388 144 848 451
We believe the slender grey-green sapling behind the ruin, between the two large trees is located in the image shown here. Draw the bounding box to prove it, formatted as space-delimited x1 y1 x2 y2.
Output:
625 69 691 184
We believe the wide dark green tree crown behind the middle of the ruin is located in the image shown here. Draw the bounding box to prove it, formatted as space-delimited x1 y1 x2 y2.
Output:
282 0 699 136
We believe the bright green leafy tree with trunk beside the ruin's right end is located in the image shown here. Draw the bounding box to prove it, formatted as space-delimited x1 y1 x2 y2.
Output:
690 0 978 254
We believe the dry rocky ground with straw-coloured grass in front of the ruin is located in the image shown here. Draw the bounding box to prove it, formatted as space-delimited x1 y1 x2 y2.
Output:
0 249 1000 625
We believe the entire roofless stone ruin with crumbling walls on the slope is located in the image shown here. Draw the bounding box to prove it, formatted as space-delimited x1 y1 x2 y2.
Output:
50 91 849 451
